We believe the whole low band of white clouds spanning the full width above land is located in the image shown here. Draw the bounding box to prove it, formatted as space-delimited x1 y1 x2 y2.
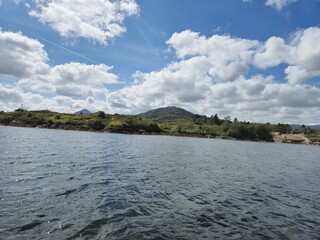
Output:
0 27 320 123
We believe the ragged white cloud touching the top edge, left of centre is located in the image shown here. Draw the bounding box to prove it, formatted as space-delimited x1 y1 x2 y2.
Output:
29 0 139 44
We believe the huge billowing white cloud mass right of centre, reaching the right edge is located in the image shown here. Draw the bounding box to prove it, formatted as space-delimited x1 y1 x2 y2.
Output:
103 29 320 122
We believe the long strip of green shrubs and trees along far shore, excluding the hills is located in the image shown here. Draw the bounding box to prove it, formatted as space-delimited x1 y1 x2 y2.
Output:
0 109 315 141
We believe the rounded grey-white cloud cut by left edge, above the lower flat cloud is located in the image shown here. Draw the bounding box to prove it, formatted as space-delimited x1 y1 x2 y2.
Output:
0 29 49 77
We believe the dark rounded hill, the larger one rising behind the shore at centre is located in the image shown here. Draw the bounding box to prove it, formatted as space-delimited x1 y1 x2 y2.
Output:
137 107 197 121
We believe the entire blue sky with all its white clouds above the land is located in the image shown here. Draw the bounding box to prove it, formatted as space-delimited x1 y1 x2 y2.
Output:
0 0 320 124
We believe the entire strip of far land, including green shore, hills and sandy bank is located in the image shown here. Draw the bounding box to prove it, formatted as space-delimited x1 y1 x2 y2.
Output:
0 107 320 145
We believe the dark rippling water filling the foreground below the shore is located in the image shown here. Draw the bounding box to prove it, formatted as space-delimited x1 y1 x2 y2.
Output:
0 127 320 239
